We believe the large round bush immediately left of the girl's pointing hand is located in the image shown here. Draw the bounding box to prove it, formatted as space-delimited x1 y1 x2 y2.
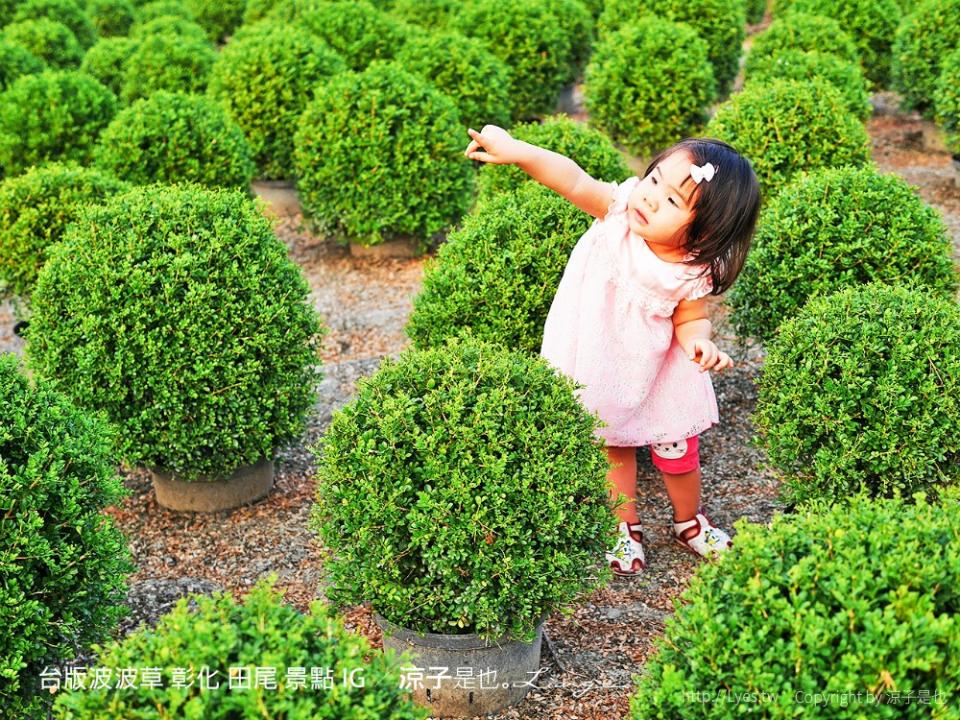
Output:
294 62 473 249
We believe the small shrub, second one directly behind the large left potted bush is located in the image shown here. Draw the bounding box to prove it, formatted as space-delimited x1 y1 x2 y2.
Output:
122 27 217 103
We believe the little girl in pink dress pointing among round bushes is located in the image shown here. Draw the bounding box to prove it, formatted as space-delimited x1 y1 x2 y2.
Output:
465 125 760 575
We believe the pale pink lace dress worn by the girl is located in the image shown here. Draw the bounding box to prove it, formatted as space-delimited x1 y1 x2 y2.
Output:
540 177 719 446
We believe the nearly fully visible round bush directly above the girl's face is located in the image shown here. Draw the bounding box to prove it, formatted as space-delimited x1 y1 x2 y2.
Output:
584 15 715 155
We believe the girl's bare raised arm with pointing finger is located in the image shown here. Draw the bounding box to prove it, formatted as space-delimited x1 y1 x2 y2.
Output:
464 125 613 218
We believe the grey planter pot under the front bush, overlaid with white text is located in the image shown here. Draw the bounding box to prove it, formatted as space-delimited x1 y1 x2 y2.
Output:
373 612 546 717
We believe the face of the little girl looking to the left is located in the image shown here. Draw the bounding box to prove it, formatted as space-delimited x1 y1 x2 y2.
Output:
627 150 697 259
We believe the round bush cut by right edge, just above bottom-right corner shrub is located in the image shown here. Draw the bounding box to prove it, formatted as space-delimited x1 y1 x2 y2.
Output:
754 284 960 503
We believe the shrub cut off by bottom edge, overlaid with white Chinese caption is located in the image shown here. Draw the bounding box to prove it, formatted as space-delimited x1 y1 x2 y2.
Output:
54 575 427 720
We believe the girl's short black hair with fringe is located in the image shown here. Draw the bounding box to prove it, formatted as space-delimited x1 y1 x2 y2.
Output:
643 138 760 295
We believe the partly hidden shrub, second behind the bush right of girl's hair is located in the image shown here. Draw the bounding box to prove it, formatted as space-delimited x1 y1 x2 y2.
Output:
744 13 860 75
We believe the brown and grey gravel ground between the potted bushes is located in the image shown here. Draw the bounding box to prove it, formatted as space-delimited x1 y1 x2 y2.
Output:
9 81 960 720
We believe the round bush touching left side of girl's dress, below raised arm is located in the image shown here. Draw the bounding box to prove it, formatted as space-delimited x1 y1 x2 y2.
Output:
406 183 593 354
